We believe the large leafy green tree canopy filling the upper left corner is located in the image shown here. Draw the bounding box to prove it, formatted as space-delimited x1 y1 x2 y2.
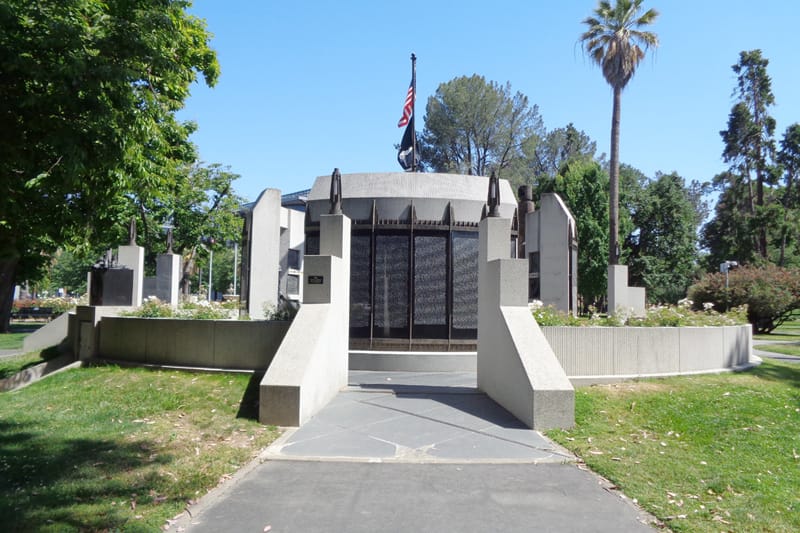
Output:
0 0 219 331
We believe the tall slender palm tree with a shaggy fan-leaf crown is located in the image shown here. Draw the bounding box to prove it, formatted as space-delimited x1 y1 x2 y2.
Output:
580 0 658 265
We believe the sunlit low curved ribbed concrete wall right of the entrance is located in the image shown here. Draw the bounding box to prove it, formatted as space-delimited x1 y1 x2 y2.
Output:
542 325 753 384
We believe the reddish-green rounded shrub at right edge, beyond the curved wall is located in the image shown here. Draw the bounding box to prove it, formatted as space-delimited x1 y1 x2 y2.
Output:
689 265 800 333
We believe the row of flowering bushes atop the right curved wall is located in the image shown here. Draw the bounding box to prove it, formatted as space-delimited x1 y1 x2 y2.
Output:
528 300 747 327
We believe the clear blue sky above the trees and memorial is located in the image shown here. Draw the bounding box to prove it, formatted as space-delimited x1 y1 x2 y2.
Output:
180 0 800 200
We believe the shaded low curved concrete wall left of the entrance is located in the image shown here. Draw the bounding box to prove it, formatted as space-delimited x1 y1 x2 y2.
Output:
97 316 290 370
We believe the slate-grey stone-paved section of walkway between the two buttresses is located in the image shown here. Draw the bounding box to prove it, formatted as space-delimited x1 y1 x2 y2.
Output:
263 372 574 463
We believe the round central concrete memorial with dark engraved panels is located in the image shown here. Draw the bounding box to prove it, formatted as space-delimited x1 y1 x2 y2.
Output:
305 172 516 351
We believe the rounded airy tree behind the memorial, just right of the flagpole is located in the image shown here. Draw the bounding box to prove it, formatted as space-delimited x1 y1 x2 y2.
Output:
421 74 543 176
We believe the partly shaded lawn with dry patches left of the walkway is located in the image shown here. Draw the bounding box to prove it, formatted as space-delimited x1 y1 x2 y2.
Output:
0 367 278 532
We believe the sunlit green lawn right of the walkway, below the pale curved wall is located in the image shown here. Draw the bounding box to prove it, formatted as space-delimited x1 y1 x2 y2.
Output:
549 362 800 532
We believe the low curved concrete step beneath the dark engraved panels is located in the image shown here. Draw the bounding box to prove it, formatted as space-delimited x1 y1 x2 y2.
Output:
350 350 478 372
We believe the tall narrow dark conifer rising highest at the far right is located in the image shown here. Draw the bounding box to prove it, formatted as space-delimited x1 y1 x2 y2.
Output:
720 50 776 260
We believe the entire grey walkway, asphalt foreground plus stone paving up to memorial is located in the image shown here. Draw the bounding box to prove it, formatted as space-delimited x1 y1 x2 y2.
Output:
169 372 653 533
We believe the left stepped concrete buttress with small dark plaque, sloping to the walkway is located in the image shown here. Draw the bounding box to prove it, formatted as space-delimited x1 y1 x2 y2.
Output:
259 215 350 426
